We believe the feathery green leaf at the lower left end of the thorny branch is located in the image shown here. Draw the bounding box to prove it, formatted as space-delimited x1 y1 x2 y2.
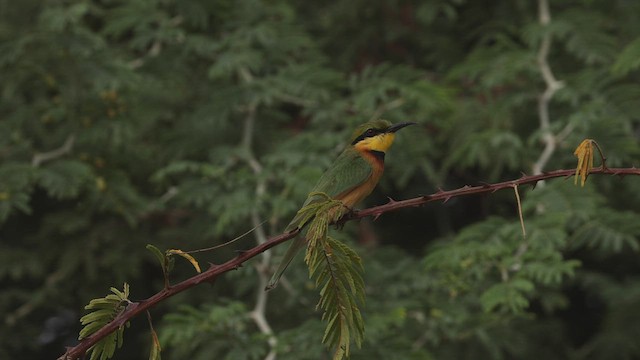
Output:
78 283 129 360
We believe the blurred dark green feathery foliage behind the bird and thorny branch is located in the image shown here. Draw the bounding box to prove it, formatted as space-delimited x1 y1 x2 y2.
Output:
0 0 640 359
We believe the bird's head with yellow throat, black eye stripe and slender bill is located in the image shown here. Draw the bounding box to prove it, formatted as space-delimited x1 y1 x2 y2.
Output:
351 120 415 152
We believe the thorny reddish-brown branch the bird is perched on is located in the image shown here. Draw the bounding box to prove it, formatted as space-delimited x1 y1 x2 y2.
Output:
58 167 640 360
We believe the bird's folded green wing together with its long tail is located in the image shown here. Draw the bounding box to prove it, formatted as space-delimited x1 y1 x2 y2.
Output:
265 149 373 290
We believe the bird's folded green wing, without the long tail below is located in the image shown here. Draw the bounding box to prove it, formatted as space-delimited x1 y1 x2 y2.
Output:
286 149 372 231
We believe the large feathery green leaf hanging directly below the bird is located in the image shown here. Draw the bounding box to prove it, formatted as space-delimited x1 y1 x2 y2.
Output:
305 204 364 360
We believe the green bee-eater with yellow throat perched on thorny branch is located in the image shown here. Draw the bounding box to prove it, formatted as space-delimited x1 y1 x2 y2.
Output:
265 119 415 290
